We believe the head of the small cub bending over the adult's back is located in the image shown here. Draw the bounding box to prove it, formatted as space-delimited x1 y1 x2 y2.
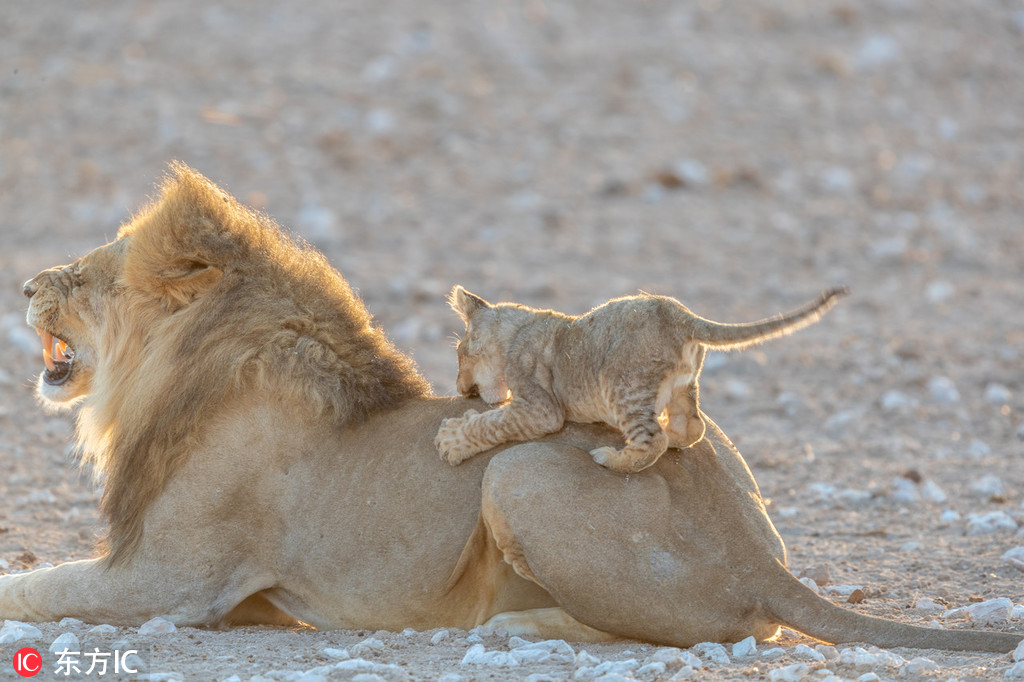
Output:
449 285 509 404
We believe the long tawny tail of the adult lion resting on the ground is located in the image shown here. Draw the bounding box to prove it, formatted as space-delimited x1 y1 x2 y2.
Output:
763 564 1024 652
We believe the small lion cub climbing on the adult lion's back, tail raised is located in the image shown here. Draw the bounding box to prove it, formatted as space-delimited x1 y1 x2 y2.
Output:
434 286 847 473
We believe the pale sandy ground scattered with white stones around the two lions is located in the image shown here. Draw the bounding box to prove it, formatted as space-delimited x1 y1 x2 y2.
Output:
0 0 1024 680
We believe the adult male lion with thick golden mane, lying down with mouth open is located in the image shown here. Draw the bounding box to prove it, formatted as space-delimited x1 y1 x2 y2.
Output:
0 165 1021 651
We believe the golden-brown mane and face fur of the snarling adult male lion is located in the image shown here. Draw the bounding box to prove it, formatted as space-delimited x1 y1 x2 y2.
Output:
24 165 430 562
